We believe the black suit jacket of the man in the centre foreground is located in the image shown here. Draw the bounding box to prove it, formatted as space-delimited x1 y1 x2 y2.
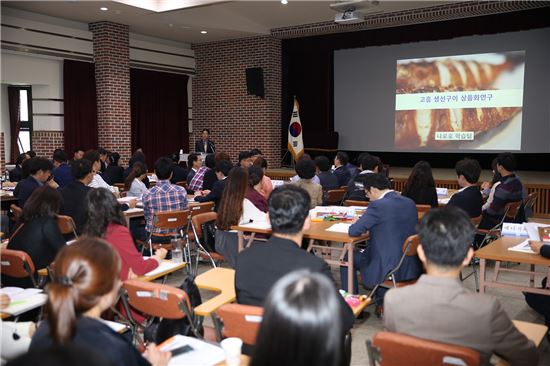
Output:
235 236 355 332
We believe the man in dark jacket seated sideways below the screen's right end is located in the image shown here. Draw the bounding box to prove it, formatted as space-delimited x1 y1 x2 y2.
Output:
479 152 523 229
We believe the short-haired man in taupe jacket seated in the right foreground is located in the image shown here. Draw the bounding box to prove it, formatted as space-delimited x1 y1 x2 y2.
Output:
384 206 538 366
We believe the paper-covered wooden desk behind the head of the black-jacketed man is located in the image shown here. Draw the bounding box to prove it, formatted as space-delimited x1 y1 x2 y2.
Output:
231 221 369 293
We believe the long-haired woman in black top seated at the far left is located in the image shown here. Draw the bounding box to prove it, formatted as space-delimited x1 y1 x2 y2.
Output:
6 186 65 288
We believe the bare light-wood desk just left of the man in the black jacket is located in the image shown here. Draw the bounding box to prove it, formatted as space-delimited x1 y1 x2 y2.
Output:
195 267 237 316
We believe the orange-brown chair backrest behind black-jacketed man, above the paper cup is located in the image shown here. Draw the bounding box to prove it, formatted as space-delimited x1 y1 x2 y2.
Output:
216 304 264 346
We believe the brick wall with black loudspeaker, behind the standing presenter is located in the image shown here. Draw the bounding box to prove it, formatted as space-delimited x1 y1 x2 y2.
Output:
189 36 281 167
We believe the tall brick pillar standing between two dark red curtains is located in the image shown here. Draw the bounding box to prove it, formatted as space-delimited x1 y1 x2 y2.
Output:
89 21 132 163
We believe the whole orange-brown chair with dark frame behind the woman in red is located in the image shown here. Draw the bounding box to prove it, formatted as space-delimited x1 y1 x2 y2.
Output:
121 280 203 340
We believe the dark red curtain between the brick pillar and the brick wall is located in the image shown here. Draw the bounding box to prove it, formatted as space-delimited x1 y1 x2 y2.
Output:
130 69 189 170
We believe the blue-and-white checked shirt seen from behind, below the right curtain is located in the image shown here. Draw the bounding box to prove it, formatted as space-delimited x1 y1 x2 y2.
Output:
142 180 187 234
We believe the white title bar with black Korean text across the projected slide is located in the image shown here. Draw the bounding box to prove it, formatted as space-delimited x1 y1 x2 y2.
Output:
395 89 523 111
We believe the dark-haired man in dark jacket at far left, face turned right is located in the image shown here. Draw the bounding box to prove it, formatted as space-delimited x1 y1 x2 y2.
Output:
13 157 58 208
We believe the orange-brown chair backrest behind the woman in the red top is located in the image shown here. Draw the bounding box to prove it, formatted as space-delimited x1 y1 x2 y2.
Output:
122 280 192 319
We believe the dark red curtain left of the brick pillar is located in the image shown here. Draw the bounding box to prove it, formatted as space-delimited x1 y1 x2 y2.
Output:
63 60 98 156
